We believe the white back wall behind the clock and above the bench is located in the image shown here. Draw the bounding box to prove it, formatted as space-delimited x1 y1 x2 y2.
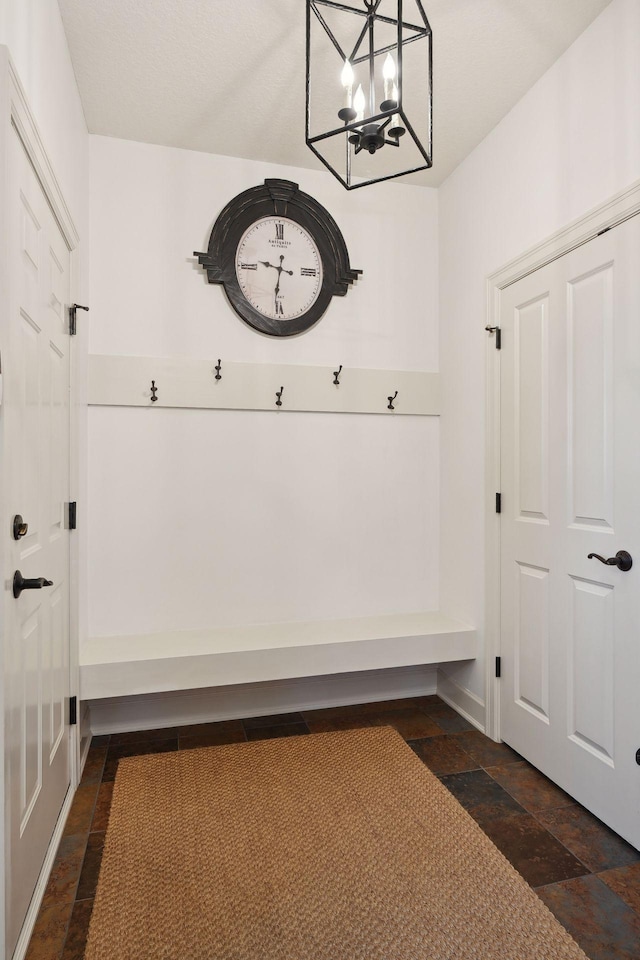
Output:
89 137 439 644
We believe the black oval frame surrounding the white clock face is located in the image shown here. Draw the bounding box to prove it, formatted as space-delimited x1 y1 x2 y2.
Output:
194 180 362 337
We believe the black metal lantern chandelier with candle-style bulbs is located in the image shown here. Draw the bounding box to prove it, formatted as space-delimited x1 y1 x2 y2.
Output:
306 0 433 190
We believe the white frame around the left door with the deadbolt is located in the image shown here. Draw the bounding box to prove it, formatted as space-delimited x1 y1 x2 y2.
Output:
0 45 80 960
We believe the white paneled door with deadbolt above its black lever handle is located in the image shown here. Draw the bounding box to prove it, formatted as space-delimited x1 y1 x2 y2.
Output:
1 128 70 957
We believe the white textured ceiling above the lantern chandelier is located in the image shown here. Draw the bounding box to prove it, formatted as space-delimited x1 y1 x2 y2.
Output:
58 0 610 186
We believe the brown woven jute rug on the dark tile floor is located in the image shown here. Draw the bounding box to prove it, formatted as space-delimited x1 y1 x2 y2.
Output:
85 727 585 960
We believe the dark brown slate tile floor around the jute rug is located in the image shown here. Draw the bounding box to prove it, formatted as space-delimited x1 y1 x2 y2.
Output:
26 696 640 960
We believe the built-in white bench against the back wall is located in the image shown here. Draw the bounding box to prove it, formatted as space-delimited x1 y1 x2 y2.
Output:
80 612 476 701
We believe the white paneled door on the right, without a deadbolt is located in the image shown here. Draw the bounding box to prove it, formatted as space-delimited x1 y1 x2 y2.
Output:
500 217 640 847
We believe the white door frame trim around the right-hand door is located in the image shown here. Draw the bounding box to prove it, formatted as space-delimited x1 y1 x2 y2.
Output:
485 180 640 740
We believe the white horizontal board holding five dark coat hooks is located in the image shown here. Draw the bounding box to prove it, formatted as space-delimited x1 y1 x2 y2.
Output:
89 354 440 416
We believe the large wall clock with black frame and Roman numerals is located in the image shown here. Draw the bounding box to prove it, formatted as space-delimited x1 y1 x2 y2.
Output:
194 180 362 337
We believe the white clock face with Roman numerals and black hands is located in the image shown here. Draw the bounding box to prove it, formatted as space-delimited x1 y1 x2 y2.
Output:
236 217 322 321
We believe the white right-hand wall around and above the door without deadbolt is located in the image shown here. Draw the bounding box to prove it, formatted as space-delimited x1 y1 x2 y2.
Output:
439 0 640 697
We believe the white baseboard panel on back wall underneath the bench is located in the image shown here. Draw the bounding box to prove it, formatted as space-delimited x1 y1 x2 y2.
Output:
90 665 436 735
